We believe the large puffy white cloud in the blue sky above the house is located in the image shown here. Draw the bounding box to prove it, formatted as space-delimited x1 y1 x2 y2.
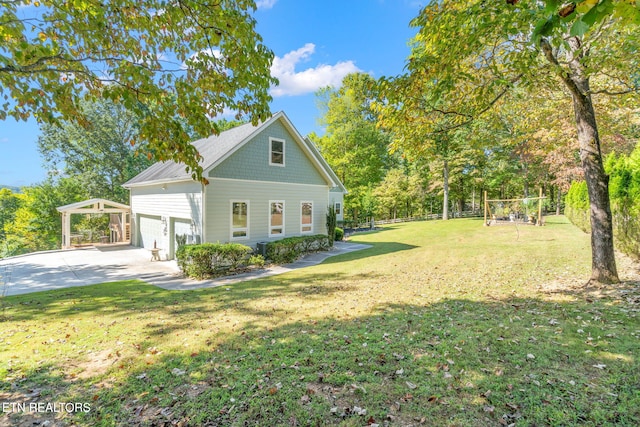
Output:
271 43 361 97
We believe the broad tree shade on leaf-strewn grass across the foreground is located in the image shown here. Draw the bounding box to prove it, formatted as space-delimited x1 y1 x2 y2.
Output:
4 288 640 426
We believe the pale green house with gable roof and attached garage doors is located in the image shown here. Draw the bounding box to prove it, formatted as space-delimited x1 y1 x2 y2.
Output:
124 112 346 259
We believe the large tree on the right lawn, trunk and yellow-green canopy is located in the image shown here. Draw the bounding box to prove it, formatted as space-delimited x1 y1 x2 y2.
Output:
388 0 640 283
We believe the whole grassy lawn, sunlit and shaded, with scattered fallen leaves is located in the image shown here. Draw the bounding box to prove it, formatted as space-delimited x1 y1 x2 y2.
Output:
0 217 640 426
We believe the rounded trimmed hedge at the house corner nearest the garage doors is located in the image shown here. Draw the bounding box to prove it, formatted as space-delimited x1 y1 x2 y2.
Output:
176 243 253 279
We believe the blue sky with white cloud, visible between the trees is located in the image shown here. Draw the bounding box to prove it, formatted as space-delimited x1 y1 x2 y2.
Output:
0 0 427 187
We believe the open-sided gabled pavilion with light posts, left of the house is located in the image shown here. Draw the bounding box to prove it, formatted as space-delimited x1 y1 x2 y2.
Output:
57 199 131 249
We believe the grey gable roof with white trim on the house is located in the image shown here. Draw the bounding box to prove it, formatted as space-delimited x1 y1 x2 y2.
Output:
123 111 346 192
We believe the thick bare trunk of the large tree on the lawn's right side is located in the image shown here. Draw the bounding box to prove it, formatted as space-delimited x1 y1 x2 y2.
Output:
540 37 620 283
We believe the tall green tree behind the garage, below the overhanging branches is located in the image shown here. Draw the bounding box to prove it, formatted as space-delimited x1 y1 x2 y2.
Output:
38 101 151 203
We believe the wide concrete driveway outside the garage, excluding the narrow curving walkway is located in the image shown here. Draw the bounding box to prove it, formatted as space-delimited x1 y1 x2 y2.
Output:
0 246 180 295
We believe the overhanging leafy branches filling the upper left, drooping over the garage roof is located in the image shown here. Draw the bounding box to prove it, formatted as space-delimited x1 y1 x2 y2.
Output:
0 0 277 183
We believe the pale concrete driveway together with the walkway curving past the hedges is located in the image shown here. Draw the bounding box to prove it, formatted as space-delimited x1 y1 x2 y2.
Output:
0 242 370 296
